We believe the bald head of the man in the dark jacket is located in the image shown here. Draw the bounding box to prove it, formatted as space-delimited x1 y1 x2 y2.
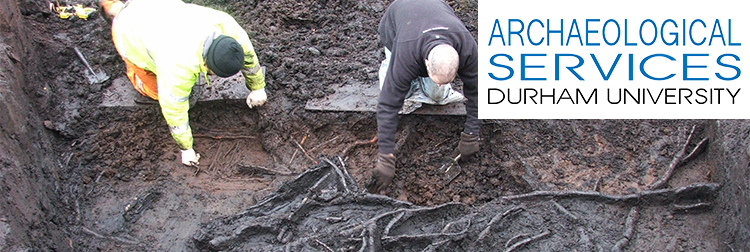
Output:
425 44 458 85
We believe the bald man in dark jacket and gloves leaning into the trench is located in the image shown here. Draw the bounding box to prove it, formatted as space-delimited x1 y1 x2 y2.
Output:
370 0 480 192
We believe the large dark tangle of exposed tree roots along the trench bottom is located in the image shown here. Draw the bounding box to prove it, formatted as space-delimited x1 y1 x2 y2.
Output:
194 156 720 252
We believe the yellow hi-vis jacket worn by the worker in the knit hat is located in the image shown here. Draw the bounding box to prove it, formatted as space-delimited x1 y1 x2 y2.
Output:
112 0 266 150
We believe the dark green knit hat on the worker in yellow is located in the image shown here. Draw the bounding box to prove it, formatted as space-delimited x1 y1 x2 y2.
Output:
206 35 245 77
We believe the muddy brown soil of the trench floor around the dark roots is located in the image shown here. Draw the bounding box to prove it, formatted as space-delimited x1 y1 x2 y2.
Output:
2 0 748 251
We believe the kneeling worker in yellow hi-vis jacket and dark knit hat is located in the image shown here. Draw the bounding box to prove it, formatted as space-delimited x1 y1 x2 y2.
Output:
99 0 266 165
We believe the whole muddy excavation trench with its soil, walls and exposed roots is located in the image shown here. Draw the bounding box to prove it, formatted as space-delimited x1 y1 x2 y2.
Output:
0 0 750 251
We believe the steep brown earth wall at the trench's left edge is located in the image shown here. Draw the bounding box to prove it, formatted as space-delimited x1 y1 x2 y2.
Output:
0 1 69 251
